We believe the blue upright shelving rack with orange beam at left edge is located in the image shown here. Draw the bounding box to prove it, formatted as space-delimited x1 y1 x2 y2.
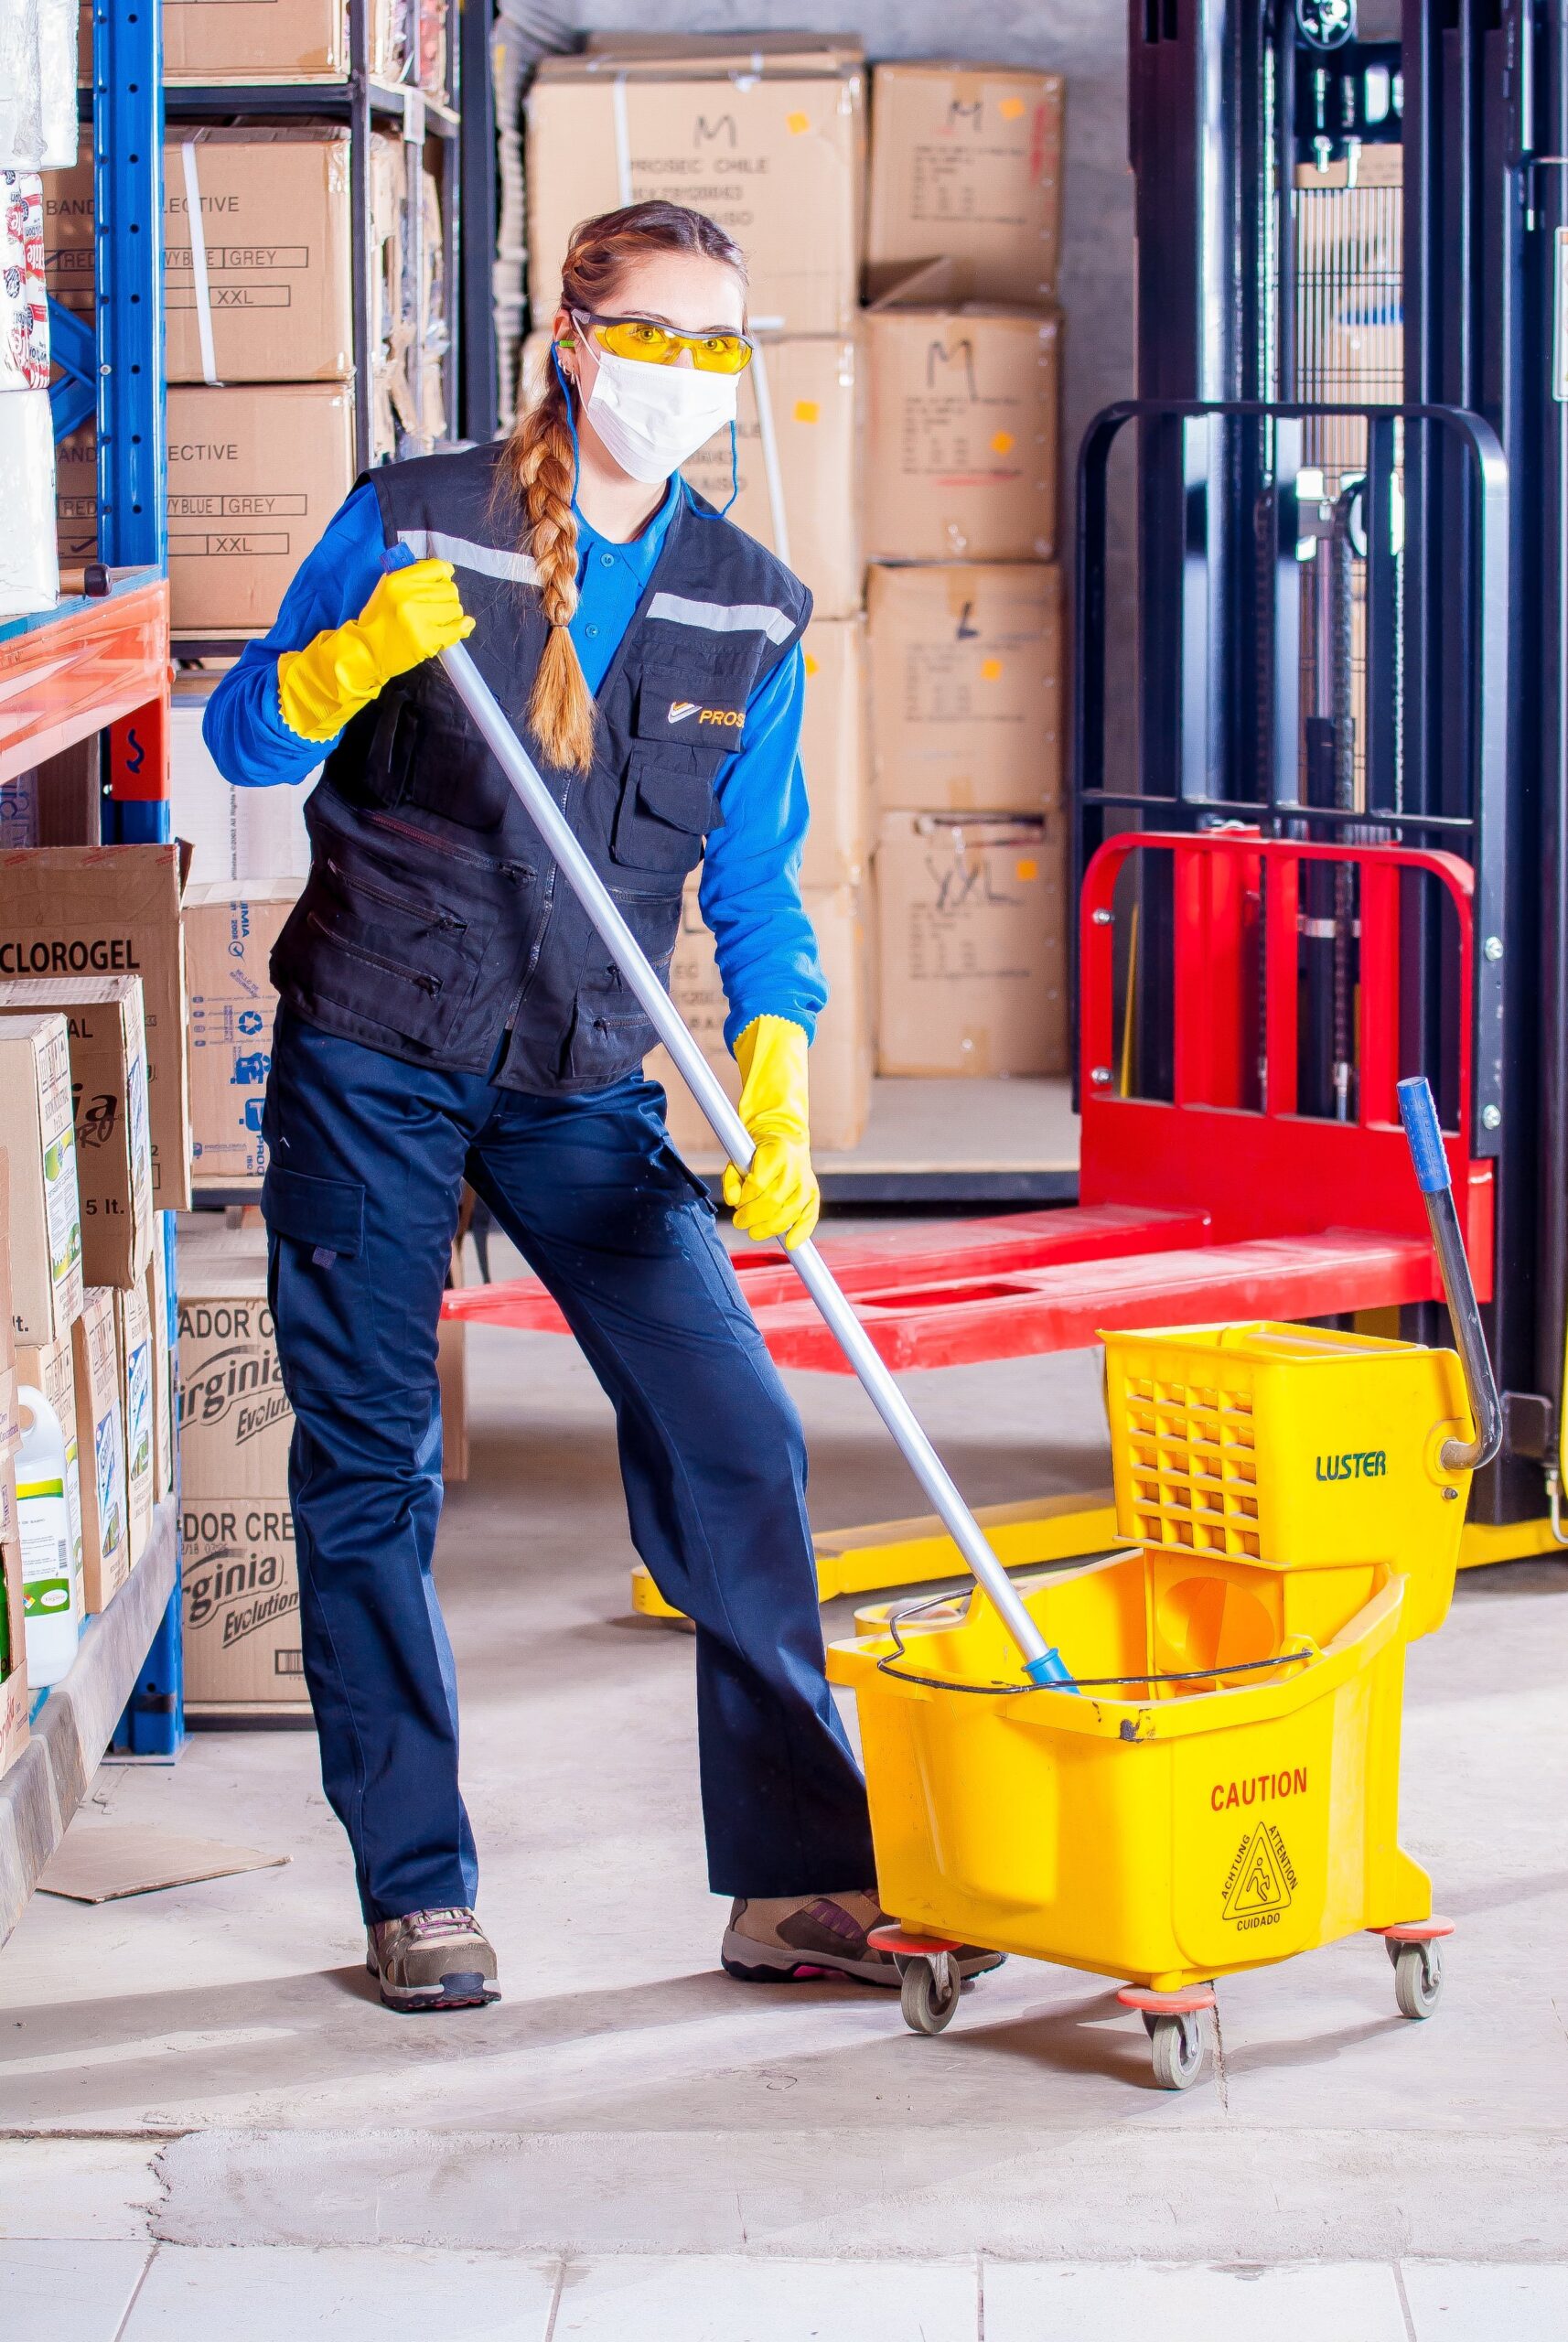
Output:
0 0 185 1941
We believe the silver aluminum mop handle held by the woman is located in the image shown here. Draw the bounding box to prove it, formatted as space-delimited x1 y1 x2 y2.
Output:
440 641 1072 1689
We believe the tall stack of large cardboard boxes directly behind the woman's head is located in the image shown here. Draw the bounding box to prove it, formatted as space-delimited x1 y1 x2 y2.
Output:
521 33 871 1155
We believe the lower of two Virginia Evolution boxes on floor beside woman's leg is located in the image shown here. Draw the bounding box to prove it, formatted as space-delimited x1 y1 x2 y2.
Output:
180 1489 309 1707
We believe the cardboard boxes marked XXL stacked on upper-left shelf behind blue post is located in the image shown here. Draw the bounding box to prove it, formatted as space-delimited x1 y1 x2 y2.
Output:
42 0 447 637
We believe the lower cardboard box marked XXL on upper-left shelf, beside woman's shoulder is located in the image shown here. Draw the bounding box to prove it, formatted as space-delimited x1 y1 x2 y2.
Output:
168 386 353 632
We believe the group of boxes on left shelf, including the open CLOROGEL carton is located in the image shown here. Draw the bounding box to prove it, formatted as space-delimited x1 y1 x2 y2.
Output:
0 845 189 1766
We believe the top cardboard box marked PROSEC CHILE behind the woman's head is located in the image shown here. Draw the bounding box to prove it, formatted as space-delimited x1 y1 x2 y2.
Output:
527 54 864 335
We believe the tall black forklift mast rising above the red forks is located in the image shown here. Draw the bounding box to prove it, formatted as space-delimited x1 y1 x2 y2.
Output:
1118 0 1568 1527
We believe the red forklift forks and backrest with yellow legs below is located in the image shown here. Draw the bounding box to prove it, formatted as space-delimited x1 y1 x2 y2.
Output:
445 827 1552 1616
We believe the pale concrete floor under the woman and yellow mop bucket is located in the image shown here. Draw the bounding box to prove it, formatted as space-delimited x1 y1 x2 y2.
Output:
0 1264 1568 2342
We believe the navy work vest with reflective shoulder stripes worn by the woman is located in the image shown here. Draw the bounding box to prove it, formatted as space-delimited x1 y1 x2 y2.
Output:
272 447 812 1094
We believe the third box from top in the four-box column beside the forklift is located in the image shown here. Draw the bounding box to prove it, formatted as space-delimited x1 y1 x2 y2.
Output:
866 562 1062 812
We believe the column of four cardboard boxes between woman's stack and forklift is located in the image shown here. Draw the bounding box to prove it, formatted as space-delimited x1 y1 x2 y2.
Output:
864 63 1068 1075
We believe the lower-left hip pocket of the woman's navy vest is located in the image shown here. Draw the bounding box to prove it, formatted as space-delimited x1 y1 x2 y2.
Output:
285 857 491 1049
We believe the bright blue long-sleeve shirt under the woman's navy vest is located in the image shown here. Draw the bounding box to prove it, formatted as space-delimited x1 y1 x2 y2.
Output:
201 478 829 1047
